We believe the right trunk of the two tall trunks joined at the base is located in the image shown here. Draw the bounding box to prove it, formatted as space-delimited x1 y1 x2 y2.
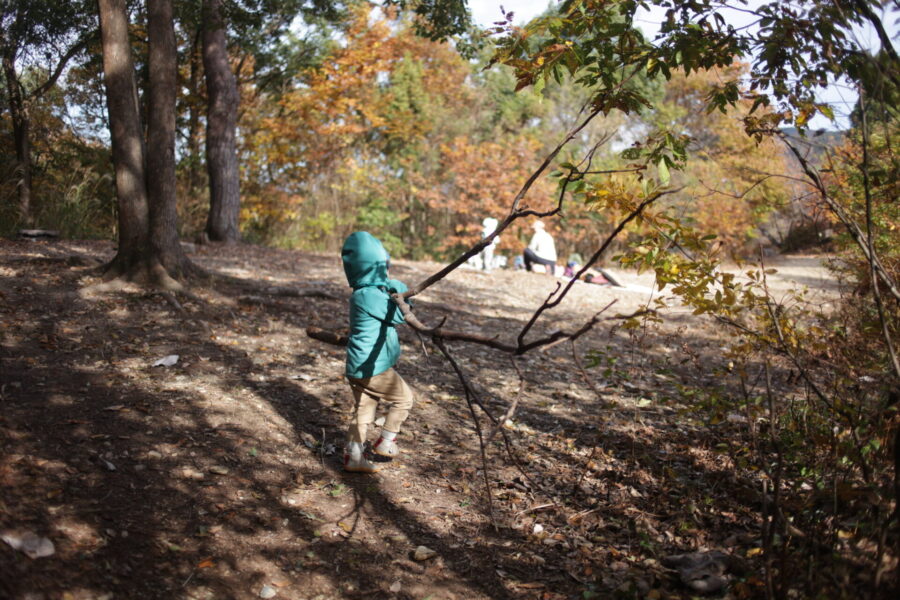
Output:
147 0 189 279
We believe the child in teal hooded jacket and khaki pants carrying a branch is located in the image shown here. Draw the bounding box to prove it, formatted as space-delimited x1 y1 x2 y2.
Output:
341 231 413 473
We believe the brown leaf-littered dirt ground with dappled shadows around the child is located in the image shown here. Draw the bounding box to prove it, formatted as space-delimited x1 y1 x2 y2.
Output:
0 240 835 600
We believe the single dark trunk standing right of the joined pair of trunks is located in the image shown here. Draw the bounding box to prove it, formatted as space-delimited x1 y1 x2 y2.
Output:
203 0 241 242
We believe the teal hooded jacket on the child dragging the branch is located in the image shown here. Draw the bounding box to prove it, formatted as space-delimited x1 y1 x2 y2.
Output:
341 231 407 379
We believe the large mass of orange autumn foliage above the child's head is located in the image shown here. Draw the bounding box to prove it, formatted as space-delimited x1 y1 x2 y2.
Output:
241 9 551 256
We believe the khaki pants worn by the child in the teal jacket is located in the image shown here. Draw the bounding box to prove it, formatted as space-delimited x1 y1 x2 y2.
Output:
347 369 414 443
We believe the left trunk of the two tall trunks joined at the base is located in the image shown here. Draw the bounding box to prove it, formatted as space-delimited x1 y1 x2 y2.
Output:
98 0 149 277
